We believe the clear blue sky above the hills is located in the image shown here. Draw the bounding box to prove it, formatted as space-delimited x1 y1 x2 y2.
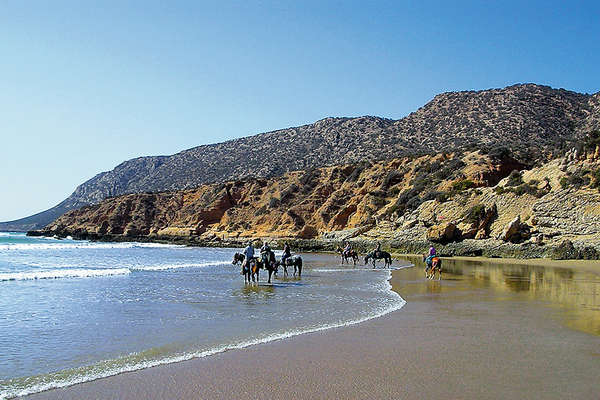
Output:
0 0 600 221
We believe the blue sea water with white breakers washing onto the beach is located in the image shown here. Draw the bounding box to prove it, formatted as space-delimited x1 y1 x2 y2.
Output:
0 233 404 399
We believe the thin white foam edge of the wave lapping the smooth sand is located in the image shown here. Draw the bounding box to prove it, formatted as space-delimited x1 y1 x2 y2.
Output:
0 266 406 399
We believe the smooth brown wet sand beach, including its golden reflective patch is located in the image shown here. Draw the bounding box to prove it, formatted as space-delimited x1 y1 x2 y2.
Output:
23 260 600 399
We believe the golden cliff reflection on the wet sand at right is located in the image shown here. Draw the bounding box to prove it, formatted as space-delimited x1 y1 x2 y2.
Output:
399 257 600 335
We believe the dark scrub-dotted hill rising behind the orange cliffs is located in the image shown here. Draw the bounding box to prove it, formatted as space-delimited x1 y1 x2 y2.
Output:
0 84 600 230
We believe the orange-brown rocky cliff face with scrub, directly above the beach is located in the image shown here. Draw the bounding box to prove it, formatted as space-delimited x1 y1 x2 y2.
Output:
43 149 600 258
